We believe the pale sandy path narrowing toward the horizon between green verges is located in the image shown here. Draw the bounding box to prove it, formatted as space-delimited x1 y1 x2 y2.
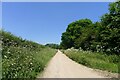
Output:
38 50 105 78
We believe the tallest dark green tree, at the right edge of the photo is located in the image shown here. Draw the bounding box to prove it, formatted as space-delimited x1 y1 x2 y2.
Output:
101 1 120 54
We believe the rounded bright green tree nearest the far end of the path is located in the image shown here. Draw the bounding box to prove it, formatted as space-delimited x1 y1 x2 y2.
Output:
61 19 92 49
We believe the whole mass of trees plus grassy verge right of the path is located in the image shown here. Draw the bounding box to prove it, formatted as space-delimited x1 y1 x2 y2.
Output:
60 1 120 73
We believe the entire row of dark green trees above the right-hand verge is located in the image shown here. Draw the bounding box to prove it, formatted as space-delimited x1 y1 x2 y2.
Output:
60 1 120 55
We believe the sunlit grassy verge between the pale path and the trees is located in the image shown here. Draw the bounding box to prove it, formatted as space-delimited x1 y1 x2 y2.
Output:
64 50 120 73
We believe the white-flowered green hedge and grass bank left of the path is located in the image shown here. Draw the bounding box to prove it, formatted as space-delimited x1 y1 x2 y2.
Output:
0 30 56 79
